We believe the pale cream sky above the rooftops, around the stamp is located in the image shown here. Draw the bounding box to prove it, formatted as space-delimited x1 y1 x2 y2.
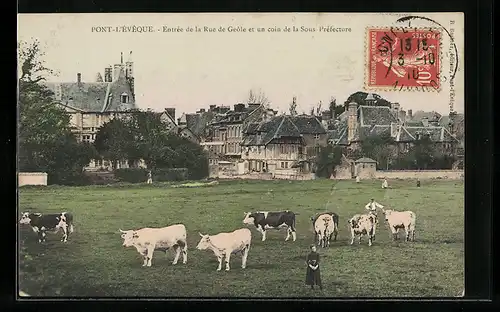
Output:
18 13 464 114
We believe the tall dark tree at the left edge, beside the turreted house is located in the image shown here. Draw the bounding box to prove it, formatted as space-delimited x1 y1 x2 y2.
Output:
18 40 93 184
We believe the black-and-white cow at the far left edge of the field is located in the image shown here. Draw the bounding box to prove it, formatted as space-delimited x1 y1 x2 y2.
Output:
19 212 74 243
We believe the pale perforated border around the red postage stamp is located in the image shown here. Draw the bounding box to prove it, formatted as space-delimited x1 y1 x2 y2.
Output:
363 26 443 93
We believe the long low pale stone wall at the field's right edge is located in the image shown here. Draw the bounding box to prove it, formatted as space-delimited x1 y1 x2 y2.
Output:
375 170 464 180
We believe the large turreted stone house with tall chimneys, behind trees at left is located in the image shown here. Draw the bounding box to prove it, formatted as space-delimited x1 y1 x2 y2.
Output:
46 52 137 169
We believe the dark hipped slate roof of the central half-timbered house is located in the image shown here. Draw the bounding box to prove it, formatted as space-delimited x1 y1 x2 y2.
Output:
242 115 326 146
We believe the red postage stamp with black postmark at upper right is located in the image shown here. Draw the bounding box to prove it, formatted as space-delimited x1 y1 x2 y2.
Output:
365 27 441 91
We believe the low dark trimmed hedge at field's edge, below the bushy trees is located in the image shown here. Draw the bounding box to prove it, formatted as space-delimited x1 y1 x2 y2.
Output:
114 168 189 183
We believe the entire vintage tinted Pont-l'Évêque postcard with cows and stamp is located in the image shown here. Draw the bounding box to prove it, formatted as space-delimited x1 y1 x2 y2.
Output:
18 12 465 299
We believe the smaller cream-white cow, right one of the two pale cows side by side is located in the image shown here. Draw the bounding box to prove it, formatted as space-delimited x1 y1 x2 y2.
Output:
196 229 252 271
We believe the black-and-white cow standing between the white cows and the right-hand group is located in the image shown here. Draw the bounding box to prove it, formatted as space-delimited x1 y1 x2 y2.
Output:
243 210 297 241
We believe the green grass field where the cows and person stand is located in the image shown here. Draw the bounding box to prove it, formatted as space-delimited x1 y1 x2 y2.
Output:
19 180 464 297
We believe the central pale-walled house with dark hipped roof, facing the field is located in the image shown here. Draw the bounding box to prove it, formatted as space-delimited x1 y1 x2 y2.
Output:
241 115 327 175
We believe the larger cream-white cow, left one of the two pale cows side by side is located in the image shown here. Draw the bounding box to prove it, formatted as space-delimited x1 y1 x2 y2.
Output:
120 224 187 267
